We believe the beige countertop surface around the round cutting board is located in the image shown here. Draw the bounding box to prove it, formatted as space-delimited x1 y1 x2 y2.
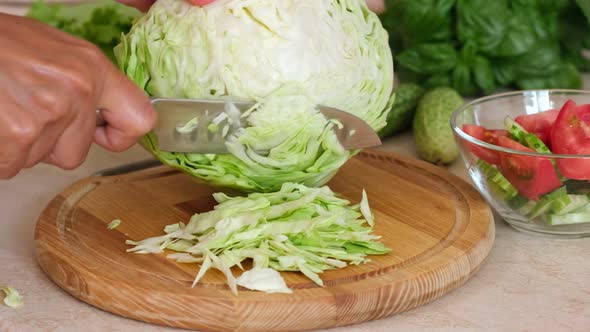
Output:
0 0 590 332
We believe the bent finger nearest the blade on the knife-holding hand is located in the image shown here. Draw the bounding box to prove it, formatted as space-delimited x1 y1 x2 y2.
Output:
94 62 156 152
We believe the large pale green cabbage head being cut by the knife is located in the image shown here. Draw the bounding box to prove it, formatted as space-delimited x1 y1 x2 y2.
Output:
115 0 394 192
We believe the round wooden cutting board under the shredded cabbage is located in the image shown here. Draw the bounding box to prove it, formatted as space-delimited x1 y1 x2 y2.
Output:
35 151 495 331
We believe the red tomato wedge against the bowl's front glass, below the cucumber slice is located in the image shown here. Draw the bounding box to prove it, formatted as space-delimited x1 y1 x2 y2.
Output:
498 136 561 200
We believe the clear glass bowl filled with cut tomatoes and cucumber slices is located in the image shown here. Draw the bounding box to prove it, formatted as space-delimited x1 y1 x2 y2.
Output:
452 90 590 236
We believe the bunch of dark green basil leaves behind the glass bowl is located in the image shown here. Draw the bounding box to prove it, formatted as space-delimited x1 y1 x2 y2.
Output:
380 0 590 96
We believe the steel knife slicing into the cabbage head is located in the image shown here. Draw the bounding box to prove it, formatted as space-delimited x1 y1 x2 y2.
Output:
96 97 381 154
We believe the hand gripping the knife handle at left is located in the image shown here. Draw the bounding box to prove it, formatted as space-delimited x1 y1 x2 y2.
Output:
0 14 156 179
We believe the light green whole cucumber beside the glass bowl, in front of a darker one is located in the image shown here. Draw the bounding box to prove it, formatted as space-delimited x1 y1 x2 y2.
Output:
412 87 464 164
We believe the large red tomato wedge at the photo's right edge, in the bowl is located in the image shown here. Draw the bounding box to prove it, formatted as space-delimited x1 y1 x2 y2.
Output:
551 100 590 180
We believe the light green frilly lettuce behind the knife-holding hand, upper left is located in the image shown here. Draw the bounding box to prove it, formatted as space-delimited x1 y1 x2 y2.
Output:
27 0 141 61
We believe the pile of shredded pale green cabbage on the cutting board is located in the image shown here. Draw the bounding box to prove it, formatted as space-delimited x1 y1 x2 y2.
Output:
126 183 390 293
